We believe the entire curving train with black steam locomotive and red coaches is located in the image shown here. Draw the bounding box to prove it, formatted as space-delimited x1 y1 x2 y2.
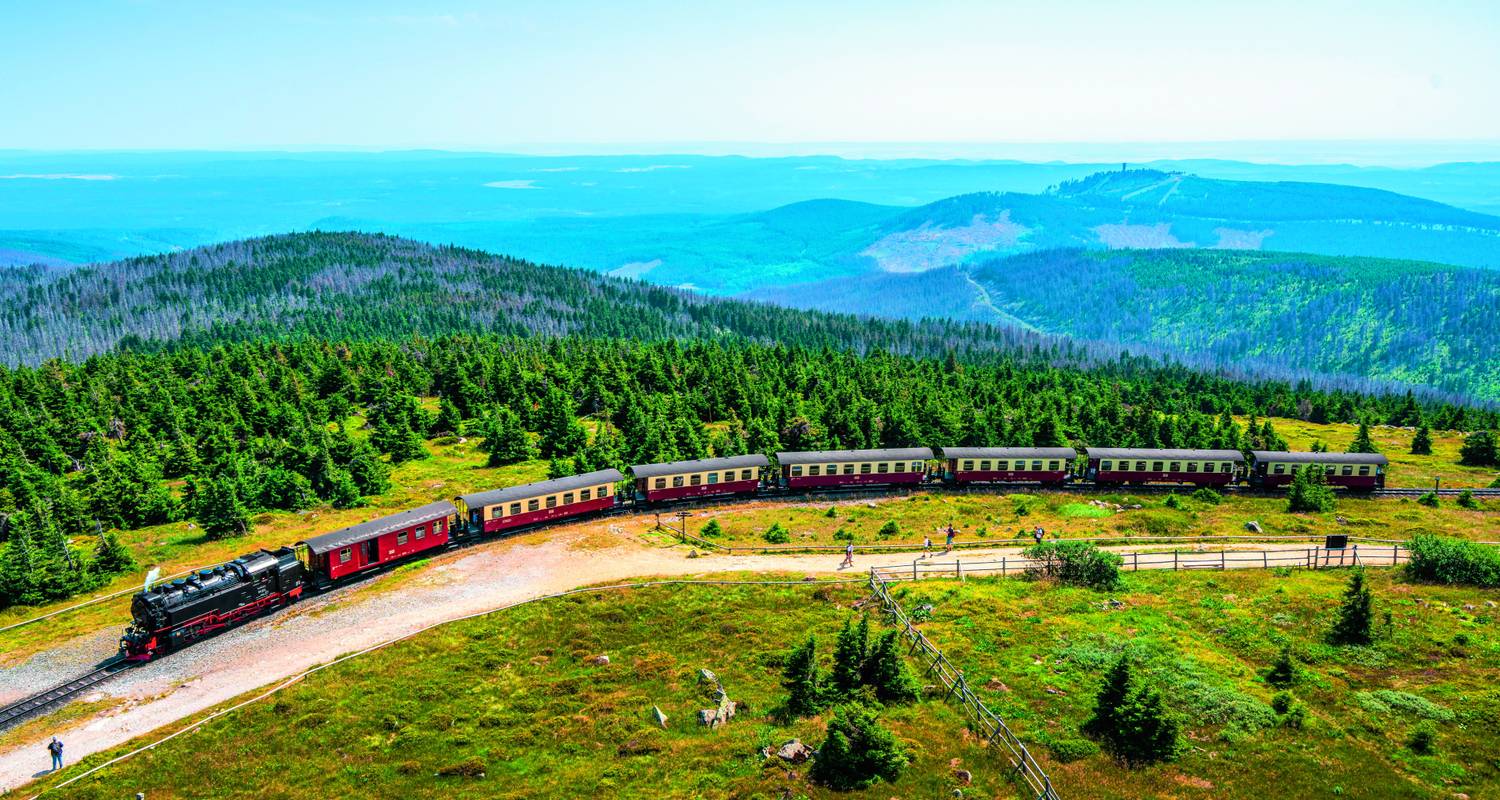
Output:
120 447 1388 660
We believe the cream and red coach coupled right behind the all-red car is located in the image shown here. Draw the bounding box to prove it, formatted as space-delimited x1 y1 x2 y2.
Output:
453 470 626 536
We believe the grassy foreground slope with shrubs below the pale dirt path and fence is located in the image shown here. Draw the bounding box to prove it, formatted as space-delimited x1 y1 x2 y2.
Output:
23 570 1500 800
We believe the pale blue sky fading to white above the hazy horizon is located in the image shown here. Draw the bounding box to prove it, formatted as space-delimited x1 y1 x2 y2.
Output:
0 0 1500 150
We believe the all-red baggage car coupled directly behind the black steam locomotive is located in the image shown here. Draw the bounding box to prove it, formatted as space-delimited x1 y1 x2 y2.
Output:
297 500 453 582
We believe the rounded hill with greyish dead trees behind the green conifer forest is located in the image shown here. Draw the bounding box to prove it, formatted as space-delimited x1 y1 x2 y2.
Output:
0 233 1086 366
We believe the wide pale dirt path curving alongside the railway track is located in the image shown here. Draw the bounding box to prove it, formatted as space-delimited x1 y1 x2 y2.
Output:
0 516 1380 791
